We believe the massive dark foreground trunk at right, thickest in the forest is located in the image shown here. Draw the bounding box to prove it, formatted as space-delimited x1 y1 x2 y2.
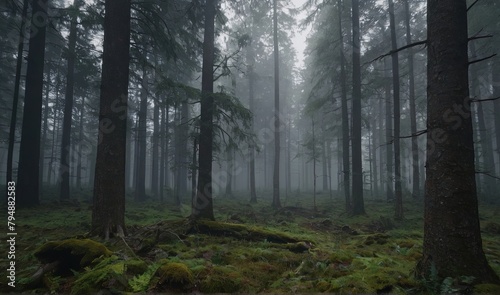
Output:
417 0 500 284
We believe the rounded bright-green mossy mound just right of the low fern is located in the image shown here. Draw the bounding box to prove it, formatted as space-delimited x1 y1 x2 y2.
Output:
150 259 194 292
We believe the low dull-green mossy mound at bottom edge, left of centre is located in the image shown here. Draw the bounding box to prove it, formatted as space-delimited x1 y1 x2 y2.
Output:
199 267 242 293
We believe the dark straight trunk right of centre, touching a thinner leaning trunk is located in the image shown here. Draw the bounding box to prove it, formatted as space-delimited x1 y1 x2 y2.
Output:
352 0 365 215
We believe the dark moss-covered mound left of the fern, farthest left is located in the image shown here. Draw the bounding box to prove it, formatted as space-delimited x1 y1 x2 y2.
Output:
34 239 112 273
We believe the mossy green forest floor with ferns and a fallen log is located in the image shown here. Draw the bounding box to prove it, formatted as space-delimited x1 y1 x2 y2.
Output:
0 188 500 294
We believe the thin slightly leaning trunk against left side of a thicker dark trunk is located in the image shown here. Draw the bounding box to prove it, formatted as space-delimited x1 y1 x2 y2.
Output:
337 0 352 212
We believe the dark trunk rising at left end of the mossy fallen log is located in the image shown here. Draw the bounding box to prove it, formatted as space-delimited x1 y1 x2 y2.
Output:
192 0 218 220
